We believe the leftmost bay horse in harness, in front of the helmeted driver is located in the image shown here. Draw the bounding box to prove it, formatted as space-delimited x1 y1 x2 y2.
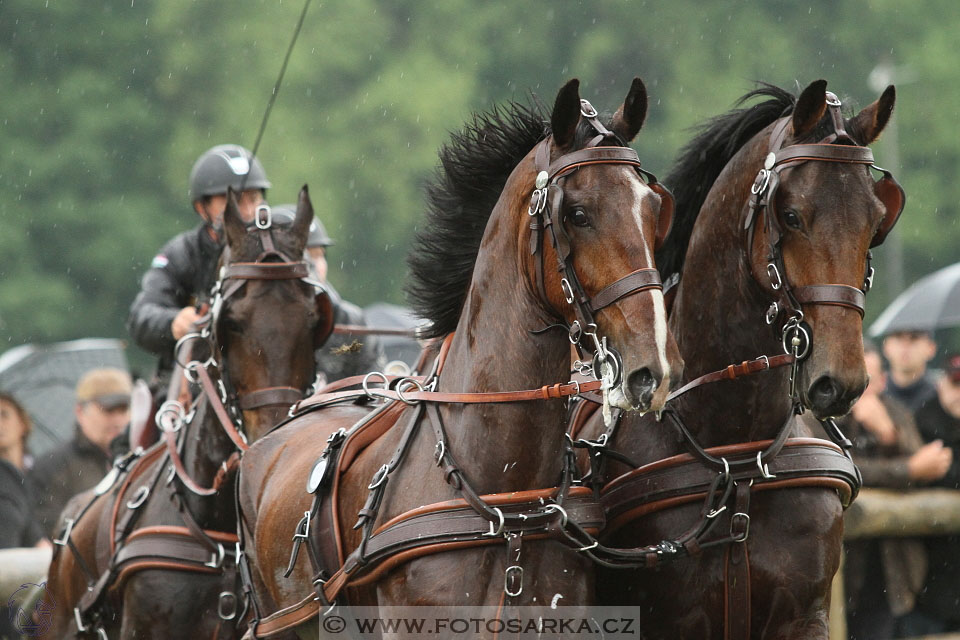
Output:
46 187 333 639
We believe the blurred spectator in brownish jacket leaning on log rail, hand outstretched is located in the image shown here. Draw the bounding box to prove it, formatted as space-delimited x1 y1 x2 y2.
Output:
841 343 952 640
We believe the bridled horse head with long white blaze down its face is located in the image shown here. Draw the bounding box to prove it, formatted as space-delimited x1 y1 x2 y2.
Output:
521 78 683 411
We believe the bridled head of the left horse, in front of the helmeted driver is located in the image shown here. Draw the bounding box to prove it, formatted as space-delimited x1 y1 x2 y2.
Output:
212 186 333 439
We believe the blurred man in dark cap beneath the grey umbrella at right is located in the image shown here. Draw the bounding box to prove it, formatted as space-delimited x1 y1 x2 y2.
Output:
883 331 937 412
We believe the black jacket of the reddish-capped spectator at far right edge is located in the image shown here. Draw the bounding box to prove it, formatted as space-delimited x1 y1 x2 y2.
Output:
916 396 960 630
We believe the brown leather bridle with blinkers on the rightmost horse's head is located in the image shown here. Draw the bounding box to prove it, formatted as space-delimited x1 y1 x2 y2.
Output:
743 91 905 392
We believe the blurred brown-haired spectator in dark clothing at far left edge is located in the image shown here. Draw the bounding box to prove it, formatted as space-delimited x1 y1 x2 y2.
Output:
0 392 50 549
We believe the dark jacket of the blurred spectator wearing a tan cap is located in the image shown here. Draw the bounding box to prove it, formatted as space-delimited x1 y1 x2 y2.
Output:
30 426 111 537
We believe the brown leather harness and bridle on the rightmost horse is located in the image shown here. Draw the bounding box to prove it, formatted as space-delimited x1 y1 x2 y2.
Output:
571 92 905 640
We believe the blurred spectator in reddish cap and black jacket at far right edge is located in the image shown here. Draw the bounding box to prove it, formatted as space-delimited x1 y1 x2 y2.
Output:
908 354 960 635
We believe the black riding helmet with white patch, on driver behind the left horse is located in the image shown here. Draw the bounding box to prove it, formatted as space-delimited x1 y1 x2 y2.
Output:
190 144 270 202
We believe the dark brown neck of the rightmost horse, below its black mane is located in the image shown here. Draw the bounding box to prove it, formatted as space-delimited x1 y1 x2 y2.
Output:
670 132 791 446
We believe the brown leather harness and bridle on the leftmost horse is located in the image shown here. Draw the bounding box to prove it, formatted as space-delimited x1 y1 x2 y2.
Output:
55 219 322 639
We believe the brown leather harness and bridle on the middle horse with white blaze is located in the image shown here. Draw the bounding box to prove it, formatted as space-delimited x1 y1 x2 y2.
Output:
243 105 672 638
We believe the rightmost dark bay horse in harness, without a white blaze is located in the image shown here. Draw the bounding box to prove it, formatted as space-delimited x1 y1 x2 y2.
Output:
580 80 904 640
